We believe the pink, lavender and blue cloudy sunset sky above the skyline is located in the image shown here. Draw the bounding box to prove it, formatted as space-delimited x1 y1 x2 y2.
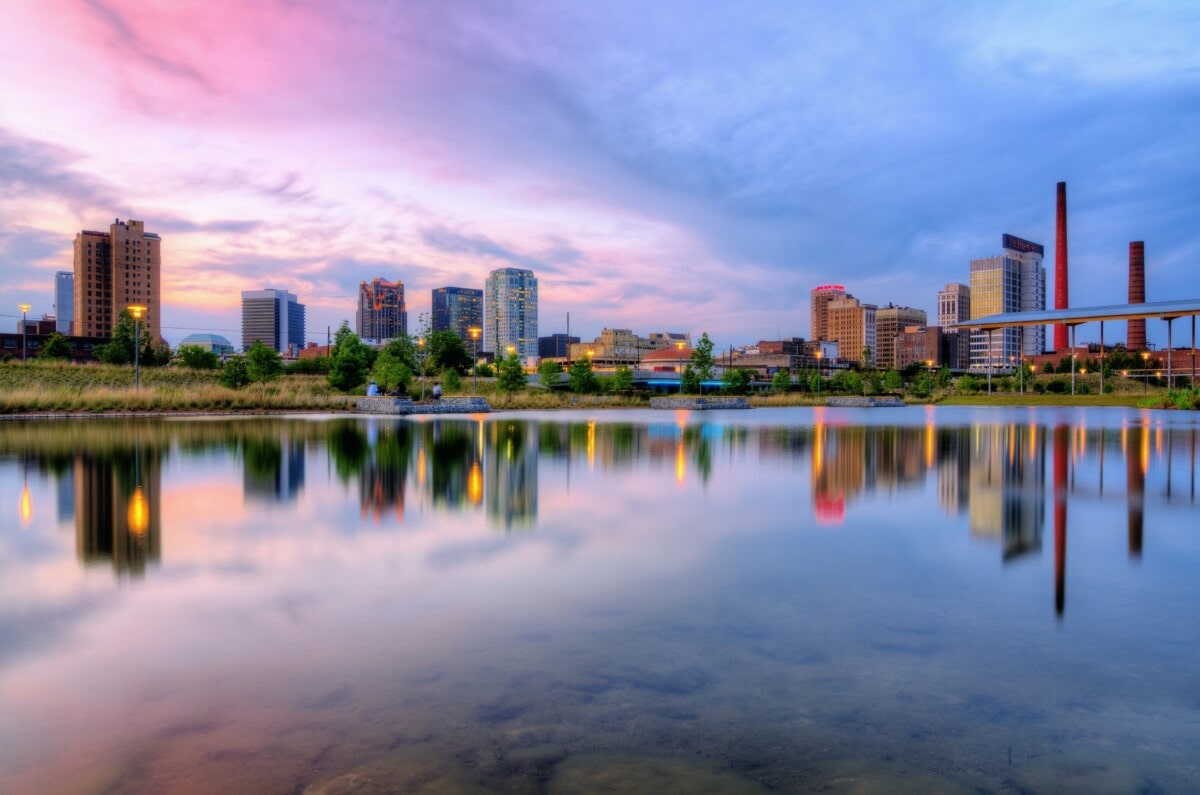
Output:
0 0 1200 349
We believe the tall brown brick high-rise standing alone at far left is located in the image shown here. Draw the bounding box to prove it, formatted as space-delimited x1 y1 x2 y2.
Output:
73 219 162 340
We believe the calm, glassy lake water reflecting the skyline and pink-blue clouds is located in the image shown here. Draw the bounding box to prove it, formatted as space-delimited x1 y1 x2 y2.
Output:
0 408 1200 793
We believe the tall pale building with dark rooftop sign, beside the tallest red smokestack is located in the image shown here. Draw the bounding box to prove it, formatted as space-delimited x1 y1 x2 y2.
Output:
971 234 1046 372
